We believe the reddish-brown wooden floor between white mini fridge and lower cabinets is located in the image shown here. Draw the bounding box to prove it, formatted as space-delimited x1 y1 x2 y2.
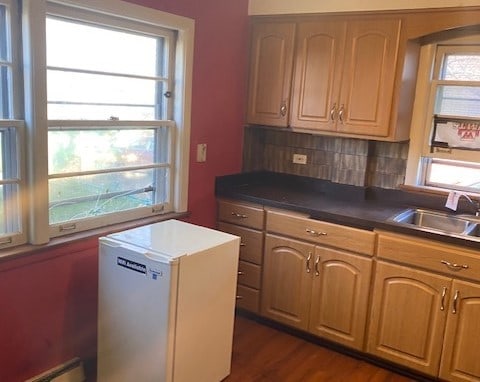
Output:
224 315 415 382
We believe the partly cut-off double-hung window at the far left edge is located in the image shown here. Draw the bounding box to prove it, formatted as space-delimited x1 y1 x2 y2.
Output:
0 0 26 247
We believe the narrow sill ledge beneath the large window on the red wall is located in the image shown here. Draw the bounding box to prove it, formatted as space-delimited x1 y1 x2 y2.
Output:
0 212 189 270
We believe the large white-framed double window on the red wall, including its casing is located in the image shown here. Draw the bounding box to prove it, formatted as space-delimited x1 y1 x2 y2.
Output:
0 0 194 247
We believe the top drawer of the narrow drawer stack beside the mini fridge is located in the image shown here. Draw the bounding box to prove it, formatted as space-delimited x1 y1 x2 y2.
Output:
218 200 264 230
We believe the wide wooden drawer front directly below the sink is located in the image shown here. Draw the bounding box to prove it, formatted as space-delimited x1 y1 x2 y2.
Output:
377 232 480 281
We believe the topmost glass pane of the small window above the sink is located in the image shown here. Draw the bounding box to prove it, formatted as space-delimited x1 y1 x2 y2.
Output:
440 54 480 81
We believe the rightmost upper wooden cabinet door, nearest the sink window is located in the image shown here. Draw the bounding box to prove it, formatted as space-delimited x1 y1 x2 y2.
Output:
337 19 400 136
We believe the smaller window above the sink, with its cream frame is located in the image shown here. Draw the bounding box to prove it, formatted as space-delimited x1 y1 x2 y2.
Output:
407 36 480 193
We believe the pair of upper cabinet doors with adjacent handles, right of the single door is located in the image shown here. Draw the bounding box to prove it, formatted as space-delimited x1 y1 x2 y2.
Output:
291 19 400 137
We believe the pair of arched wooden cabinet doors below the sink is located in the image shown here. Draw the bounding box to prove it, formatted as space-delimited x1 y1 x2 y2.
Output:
367 261 480 381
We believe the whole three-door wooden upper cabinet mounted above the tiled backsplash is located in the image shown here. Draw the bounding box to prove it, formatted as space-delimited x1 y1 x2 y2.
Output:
247 14 419 141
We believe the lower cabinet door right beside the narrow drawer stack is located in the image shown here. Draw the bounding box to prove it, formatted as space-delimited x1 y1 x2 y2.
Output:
261 235 315 330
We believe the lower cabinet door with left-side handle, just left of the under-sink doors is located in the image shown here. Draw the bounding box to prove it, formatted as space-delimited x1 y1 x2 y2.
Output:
309 247 372 350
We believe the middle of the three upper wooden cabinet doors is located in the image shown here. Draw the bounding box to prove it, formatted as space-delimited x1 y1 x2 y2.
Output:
291 21 346 131
